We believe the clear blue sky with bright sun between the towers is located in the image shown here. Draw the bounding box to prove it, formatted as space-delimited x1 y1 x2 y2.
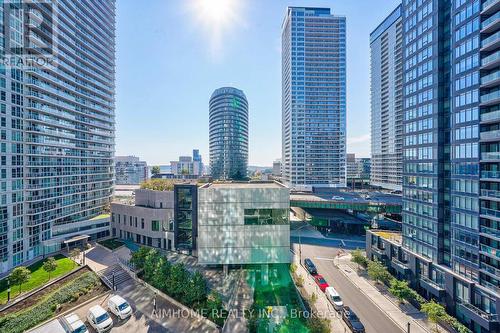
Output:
116 0 400 166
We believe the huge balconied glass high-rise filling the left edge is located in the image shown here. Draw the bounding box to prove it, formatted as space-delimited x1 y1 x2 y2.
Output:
0 0 115 274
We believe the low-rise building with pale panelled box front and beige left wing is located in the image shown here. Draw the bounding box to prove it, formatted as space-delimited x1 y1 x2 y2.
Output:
111 182 290 265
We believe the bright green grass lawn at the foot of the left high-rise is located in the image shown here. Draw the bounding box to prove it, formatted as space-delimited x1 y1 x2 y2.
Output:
0 254 78 304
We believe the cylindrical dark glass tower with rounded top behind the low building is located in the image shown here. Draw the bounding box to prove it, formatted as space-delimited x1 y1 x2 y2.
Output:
209 87 248 180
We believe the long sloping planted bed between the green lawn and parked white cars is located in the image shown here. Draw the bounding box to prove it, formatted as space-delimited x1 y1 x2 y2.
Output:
0 267 107 333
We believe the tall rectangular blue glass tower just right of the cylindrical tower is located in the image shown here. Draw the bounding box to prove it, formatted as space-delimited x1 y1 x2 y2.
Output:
282 7 346 187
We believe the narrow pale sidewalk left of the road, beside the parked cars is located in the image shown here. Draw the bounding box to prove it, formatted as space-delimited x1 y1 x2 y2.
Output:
293 255 349 332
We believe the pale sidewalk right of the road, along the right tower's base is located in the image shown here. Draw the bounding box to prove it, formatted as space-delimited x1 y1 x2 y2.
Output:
335 254 436 333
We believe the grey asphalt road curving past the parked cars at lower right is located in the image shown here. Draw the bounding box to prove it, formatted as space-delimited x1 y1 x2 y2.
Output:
292 241 404 333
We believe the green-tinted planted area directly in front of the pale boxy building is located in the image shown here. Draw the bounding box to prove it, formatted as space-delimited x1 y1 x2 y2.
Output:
247 264 310 333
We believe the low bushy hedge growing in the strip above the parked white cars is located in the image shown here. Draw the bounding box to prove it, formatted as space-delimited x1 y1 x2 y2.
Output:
0 272 100 333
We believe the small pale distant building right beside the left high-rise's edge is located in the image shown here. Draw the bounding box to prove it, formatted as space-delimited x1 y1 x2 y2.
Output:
115 156 148 185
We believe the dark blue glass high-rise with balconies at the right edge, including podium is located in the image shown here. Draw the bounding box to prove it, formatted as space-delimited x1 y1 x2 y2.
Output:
367 0 500 332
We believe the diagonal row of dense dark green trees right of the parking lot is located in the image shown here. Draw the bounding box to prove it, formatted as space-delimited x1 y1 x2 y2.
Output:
130 247 226 326
